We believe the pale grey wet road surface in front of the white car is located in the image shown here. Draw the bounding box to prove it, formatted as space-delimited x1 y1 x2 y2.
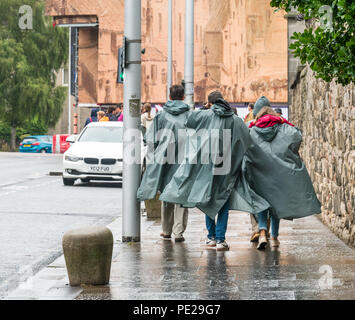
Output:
0 152 122 299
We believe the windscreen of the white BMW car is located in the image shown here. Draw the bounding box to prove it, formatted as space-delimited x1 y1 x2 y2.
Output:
78 127 123 143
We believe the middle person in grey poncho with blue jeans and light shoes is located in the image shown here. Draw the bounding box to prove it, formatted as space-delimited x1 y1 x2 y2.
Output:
160 91 251 250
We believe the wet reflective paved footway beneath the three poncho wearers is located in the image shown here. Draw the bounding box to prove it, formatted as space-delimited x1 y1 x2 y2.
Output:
76 210 355 300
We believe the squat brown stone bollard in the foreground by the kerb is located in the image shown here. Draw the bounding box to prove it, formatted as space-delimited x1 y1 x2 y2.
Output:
63 227 113 286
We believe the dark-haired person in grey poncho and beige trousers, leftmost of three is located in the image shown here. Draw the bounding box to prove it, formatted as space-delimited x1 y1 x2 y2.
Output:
137 85 190 242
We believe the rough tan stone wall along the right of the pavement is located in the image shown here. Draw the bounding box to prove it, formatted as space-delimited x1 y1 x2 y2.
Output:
290 66 355 246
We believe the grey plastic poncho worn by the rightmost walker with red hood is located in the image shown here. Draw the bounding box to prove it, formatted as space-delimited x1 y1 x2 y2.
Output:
232 124 321 219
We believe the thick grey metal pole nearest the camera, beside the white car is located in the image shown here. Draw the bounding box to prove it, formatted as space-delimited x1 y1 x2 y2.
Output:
122 0 141 242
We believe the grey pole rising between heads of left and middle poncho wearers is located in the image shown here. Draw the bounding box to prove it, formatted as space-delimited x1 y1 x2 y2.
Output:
184 0 195 108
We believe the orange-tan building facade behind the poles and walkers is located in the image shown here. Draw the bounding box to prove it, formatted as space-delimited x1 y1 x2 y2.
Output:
45 0 288 105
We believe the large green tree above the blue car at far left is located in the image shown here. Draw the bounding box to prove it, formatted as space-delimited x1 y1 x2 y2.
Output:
0 0 68 149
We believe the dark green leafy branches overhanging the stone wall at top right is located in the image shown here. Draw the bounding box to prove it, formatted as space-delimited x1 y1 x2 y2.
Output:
271 0 355 85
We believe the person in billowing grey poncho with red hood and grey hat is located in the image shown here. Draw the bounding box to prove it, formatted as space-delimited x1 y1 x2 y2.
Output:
236 97 321 249
